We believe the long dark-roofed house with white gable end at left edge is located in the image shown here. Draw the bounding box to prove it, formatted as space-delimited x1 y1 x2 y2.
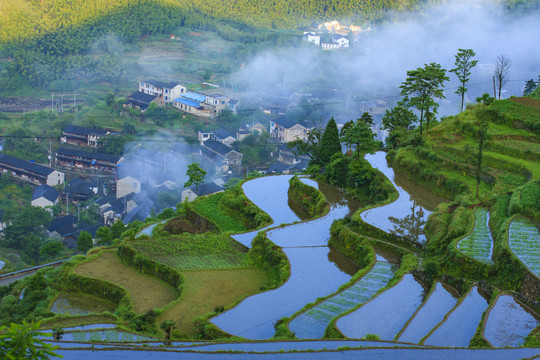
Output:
0 154 65 186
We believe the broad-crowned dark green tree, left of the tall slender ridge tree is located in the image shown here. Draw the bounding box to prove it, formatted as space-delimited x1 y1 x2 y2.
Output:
400 63 448 134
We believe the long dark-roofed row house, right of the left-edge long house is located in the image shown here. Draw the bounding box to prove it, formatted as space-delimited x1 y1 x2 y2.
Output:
55 148 124 173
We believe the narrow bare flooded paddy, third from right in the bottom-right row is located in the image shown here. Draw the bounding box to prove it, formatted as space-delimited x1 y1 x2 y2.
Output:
398 282 458 344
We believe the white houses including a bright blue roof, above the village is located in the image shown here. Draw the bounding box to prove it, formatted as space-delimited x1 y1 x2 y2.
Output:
124 80 236 117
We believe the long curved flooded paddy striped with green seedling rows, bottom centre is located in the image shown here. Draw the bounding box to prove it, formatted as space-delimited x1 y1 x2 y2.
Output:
289 261 396 339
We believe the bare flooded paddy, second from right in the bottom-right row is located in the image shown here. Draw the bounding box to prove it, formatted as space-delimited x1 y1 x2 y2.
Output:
424 286 488 347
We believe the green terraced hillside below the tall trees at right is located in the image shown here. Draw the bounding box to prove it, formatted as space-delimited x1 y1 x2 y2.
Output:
388 98 540 294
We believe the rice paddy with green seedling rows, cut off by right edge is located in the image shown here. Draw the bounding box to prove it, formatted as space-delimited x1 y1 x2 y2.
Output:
508 218 540 278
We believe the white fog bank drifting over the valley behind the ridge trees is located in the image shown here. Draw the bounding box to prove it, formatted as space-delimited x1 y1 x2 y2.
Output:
233 1 540 116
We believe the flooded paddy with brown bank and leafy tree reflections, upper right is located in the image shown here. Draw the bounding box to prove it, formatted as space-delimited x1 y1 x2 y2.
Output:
360 151 444 244
